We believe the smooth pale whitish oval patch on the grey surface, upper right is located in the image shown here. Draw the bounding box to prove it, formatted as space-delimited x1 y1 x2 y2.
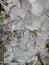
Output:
31 3 43 17
